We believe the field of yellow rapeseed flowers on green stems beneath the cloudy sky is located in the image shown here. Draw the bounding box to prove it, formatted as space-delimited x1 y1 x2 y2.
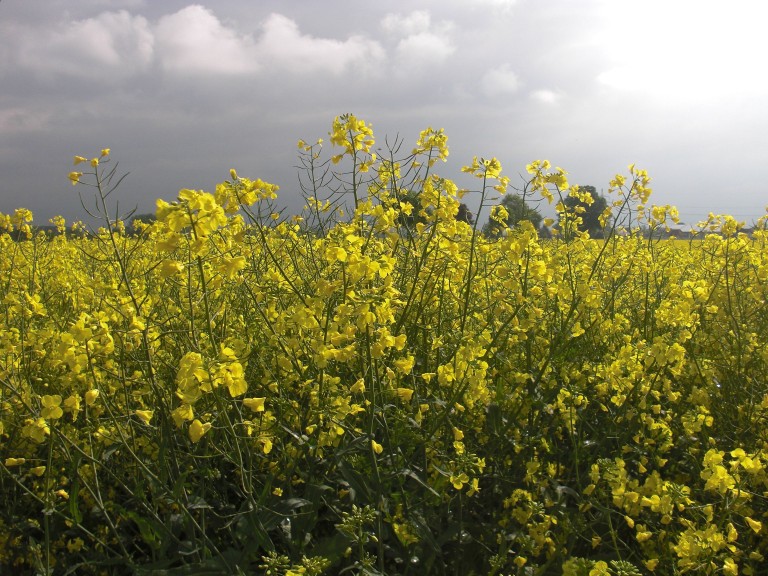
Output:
0 115 768 576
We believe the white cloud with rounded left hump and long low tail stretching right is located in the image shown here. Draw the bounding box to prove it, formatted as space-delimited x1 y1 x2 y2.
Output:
257 14 385 75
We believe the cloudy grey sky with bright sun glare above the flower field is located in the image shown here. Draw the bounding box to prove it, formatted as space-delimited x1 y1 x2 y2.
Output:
0 0 768 224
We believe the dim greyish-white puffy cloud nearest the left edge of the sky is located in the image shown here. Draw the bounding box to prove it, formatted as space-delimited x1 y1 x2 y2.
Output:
18 10 153 80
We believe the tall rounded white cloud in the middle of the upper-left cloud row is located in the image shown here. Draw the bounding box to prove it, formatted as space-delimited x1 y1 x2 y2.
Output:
155 4 260 74
